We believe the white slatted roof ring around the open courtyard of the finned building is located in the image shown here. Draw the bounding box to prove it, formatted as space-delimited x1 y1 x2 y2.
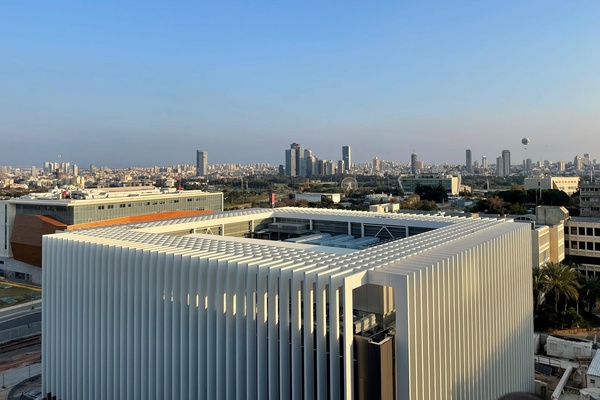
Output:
58 207 515 274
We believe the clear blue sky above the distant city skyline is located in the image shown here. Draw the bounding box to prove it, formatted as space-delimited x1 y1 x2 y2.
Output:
0 0 600 166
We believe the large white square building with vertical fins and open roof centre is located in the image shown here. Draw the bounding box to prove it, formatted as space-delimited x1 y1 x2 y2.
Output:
42 208 534 399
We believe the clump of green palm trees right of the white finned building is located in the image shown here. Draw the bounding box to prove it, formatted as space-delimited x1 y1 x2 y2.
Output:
533 263 600 329
